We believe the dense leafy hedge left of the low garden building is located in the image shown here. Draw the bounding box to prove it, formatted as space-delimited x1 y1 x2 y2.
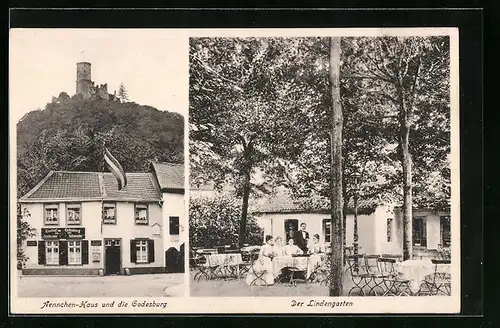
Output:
189 196 264 248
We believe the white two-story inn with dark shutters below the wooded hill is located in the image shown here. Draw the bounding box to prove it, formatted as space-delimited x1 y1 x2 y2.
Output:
19 163 186 275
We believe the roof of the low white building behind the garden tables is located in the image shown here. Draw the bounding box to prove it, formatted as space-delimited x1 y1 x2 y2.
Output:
252 190 381 214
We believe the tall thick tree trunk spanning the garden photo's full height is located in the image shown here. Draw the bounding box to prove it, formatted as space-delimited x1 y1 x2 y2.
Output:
330 37 344 296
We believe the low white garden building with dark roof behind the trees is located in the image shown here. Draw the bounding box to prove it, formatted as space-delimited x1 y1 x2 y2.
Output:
253 193 451 254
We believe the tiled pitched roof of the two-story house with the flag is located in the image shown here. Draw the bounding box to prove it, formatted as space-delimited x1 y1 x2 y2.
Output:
19 171 162 202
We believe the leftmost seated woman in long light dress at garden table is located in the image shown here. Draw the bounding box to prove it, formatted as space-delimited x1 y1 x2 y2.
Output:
246 235 275 286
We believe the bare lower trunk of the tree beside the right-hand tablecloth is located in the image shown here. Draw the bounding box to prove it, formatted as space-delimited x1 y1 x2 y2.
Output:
400 121 413 261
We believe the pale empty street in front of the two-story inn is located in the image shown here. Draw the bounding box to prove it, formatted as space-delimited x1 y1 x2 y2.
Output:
17 273 184 297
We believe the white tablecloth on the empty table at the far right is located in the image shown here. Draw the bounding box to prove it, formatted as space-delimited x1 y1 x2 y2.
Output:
395 259 450 292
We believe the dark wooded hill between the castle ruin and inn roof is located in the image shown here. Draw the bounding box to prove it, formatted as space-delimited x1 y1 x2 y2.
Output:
17 92 184 197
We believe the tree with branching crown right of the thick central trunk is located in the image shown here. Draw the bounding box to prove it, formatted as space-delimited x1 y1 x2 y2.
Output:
346 37 449 260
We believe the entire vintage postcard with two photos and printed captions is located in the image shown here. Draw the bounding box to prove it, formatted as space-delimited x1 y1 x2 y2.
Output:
10 28 460 314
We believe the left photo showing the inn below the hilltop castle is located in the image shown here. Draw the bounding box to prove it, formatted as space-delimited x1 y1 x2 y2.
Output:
9 29 188 297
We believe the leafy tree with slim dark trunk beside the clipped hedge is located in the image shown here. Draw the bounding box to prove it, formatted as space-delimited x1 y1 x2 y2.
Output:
190 38 322 247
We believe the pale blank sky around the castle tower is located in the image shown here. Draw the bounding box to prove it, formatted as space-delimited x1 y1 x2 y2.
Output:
9 29 189 123
